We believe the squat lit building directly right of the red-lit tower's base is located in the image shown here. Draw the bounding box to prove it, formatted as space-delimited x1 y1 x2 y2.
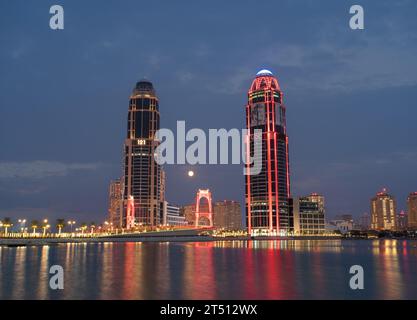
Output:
293 193 326 235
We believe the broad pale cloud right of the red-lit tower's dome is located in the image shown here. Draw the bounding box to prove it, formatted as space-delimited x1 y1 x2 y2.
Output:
263 38 417 92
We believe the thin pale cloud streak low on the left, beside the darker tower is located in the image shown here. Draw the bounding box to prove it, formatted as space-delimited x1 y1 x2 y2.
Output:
0 160 101 179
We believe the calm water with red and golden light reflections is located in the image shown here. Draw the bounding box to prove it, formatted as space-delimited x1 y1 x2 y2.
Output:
0 240 417 299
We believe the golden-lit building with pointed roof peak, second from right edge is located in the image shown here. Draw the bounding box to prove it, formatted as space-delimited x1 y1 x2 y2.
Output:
371 188 396 230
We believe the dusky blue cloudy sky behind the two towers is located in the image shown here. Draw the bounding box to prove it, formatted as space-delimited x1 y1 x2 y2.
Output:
0 0 417 222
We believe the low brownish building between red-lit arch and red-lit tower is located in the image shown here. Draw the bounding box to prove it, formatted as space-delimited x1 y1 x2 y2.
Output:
214 200 242 230
